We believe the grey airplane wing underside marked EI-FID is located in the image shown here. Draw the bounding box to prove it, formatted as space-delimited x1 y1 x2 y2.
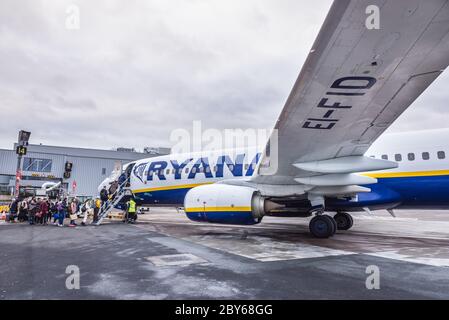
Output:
253 0 449 185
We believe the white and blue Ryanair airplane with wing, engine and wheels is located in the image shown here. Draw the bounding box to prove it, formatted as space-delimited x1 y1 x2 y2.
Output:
99 0 449 238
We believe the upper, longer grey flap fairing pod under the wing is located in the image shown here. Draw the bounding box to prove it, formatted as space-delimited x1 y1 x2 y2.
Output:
293 156 398 173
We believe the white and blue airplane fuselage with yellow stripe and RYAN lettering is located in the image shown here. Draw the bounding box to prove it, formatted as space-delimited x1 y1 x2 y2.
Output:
102 129 449 211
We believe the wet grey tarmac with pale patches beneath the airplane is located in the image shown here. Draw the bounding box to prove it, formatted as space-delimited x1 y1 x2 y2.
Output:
0 208 449 300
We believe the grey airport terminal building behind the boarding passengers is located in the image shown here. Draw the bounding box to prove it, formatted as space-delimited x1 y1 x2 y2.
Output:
0 144 170 197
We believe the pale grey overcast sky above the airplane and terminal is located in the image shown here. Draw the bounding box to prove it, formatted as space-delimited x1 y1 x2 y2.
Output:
0 0 449 149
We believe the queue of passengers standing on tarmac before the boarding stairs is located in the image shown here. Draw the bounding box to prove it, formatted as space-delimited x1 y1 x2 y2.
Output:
6 197 102 227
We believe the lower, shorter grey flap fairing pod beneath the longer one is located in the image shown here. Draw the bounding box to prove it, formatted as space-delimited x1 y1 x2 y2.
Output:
295 173 377 186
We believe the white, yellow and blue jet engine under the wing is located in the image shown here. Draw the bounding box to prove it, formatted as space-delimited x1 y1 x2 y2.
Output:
184 184 277 225
